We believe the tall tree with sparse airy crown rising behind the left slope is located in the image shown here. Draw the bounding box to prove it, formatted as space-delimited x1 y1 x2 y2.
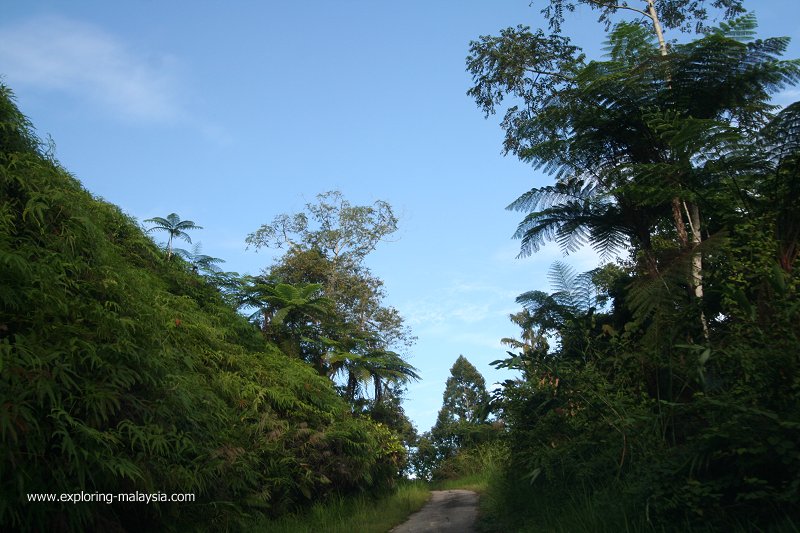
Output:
247 191 418 404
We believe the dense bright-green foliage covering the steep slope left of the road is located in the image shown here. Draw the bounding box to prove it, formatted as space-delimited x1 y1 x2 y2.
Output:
0 86 405 531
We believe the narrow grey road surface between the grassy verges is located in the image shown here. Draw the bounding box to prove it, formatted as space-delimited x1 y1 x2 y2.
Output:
389 490 478 533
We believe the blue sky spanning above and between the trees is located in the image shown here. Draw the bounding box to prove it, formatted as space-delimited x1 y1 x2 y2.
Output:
0 0 800 431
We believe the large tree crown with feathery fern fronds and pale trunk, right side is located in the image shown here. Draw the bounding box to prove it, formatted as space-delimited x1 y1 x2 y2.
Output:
468 17 798 339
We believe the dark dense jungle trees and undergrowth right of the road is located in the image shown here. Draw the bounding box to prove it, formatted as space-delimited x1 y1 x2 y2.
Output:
468 5 800 531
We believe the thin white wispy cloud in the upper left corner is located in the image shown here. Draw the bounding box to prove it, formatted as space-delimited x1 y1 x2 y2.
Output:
0 16 183 122
